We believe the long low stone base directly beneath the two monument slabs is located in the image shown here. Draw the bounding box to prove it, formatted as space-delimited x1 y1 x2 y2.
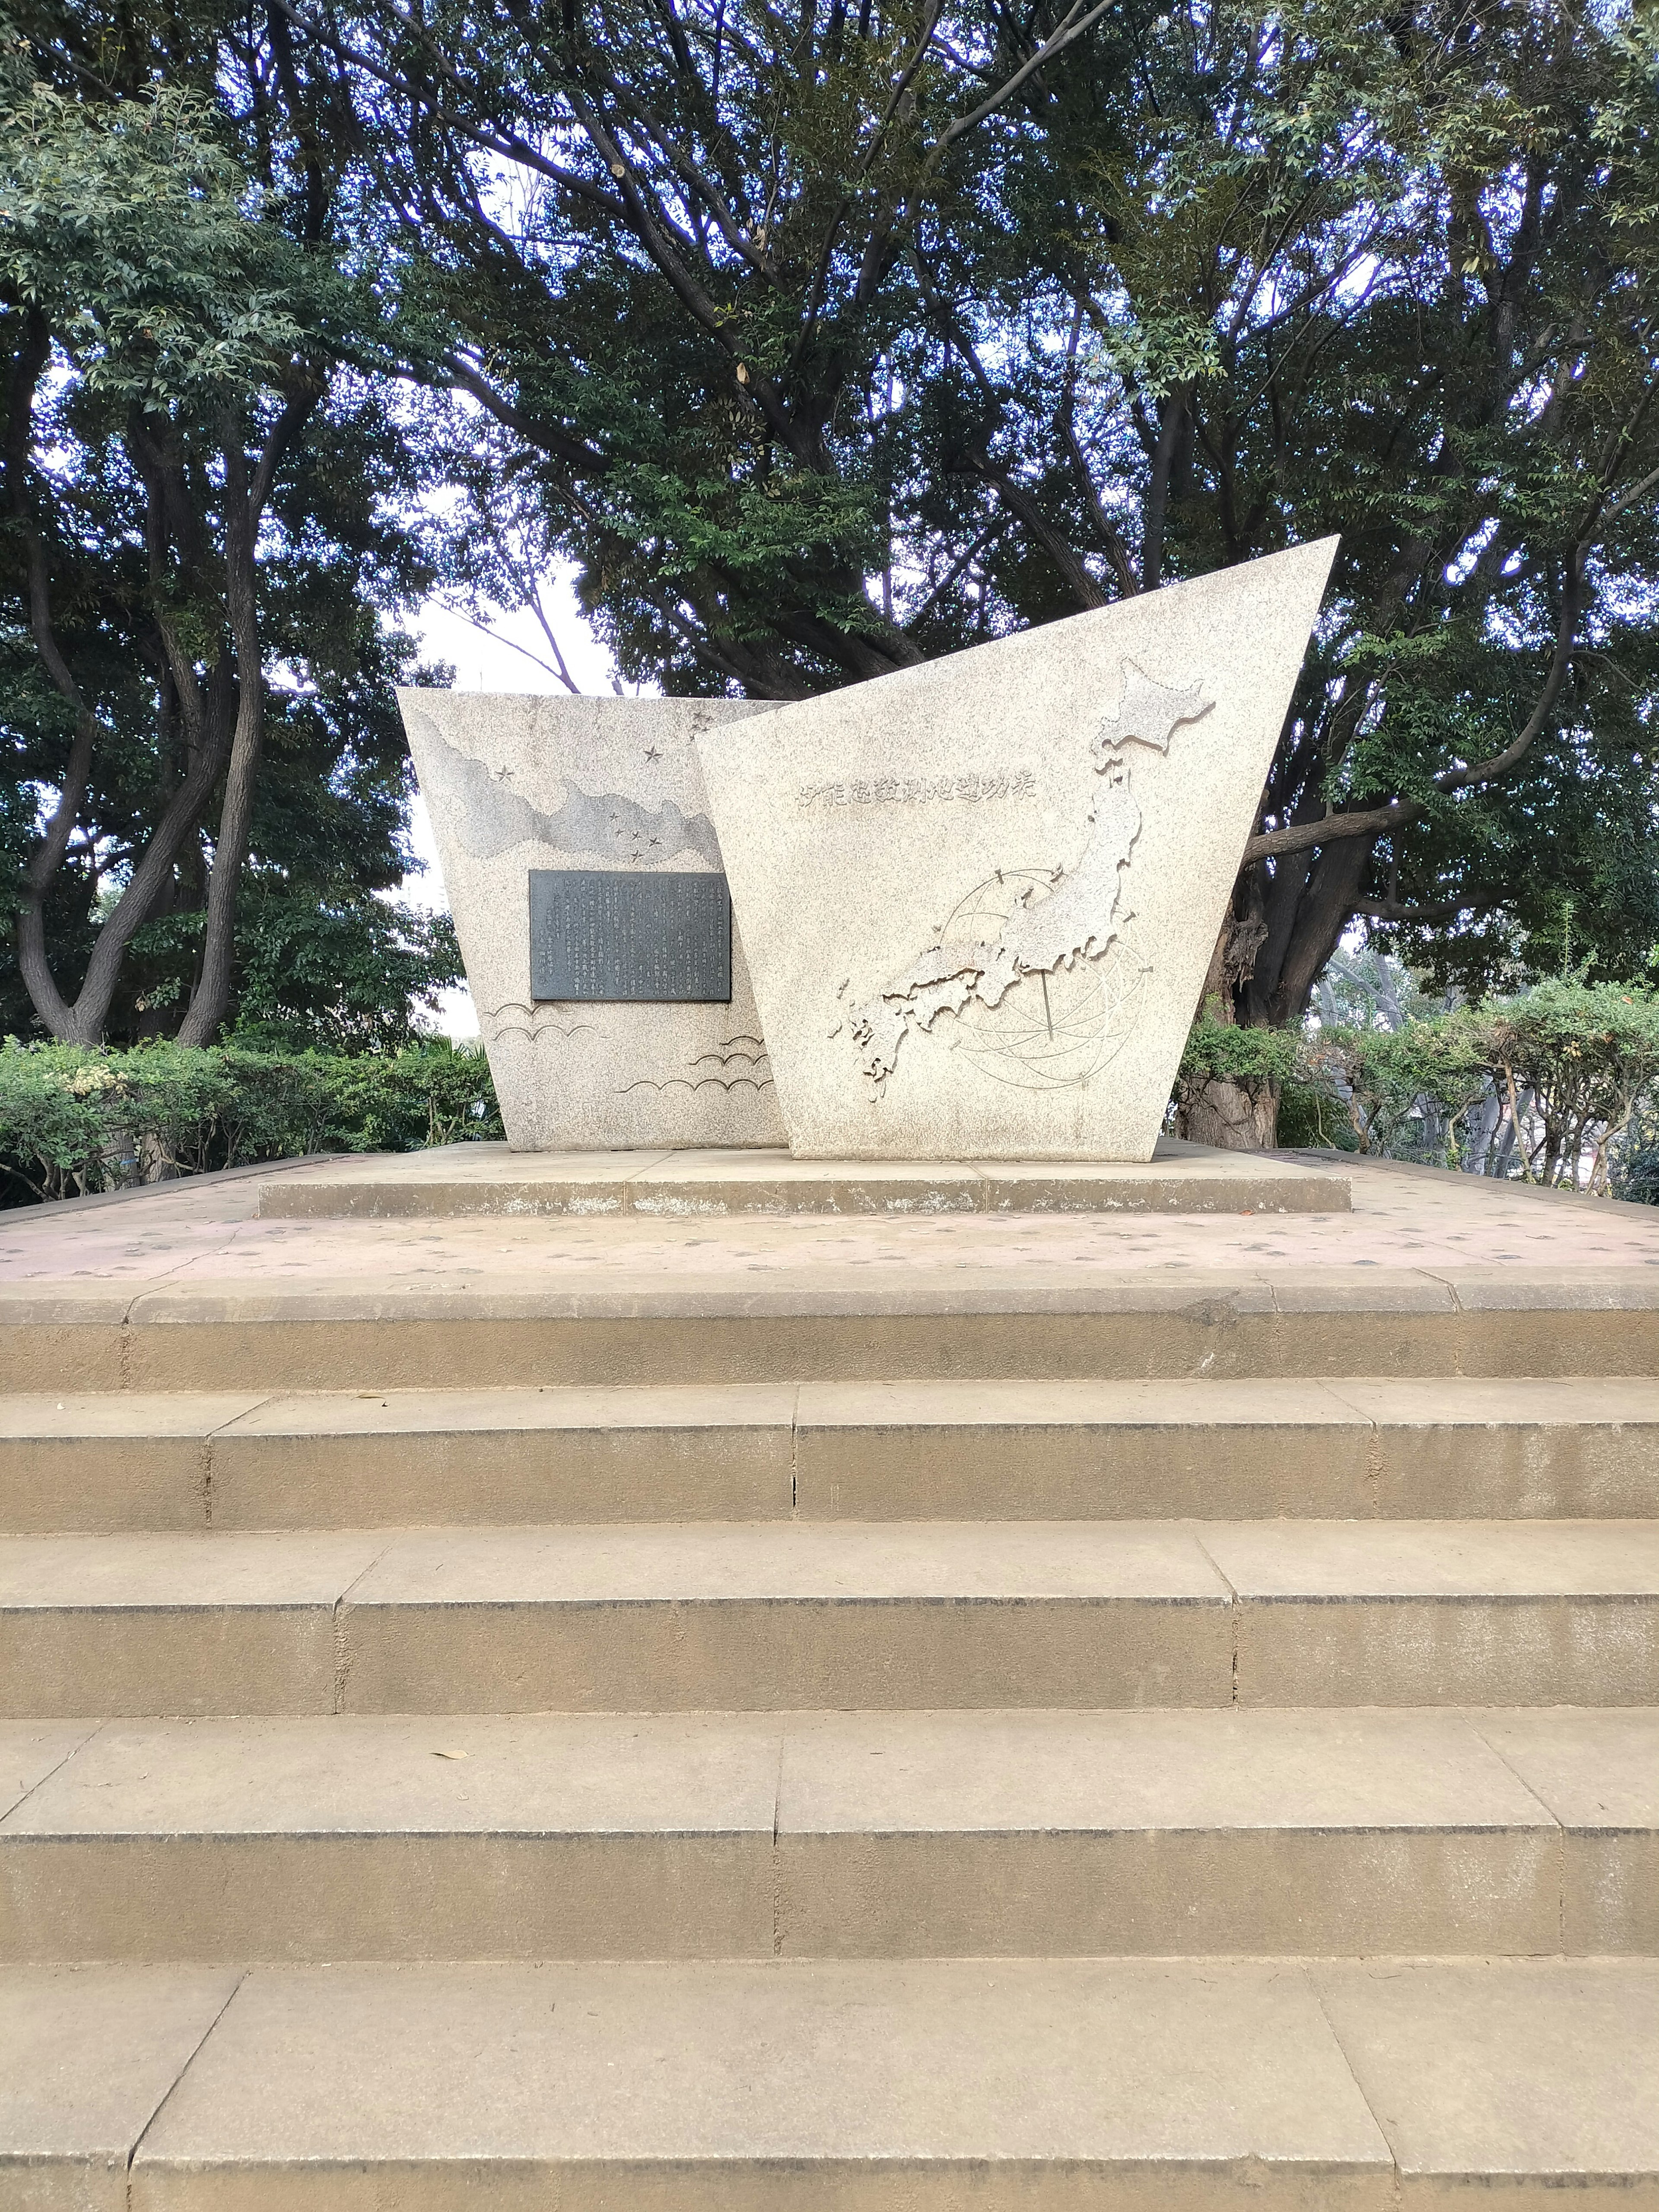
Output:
259 1137 1351 1221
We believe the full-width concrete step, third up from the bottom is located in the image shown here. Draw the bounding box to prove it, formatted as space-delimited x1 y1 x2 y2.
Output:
0 1522 1659 1716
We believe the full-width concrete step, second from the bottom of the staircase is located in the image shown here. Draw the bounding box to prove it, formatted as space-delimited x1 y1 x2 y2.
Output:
0 1708 1659 1962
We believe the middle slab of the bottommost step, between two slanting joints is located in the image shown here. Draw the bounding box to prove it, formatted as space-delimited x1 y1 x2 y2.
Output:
133 1960 1396 2212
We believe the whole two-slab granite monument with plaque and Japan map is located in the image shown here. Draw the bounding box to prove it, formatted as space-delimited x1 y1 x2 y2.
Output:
398 537 1336 1161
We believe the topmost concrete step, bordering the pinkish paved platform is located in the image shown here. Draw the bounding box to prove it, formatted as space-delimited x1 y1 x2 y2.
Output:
0 1274 1659 1394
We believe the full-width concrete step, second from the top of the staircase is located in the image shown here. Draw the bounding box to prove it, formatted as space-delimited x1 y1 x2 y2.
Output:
0 1376 1659 1531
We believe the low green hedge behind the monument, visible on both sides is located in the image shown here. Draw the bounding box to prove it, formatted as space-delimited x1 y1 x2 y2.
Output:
13 980 1659 1205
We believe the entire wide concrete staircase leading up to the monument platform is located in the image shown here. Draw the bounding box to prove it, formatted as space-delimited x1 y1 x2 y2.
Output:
0 1281 1659 2212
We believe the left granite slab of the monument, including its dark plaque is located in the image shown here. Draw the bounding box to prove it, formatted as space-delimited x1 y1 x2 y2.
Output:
398 690 785 1153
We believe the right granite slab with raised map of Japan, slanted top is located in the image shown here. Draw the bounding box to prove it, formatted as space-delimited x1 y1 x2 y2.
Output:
697 537 1336 1161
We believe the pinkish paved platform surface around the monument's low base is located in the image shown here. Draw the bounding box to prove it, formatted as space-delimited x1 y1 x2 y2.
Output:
0 1153 1659 1303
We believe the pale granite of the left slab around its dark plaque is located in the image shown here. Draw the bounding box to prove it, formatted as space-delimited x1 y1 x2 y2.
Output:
398 690 783 1150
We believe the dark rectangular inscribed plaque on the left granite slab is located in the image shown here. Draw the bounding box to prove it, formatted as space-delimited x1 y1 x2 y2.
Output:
531 867 732 1004
